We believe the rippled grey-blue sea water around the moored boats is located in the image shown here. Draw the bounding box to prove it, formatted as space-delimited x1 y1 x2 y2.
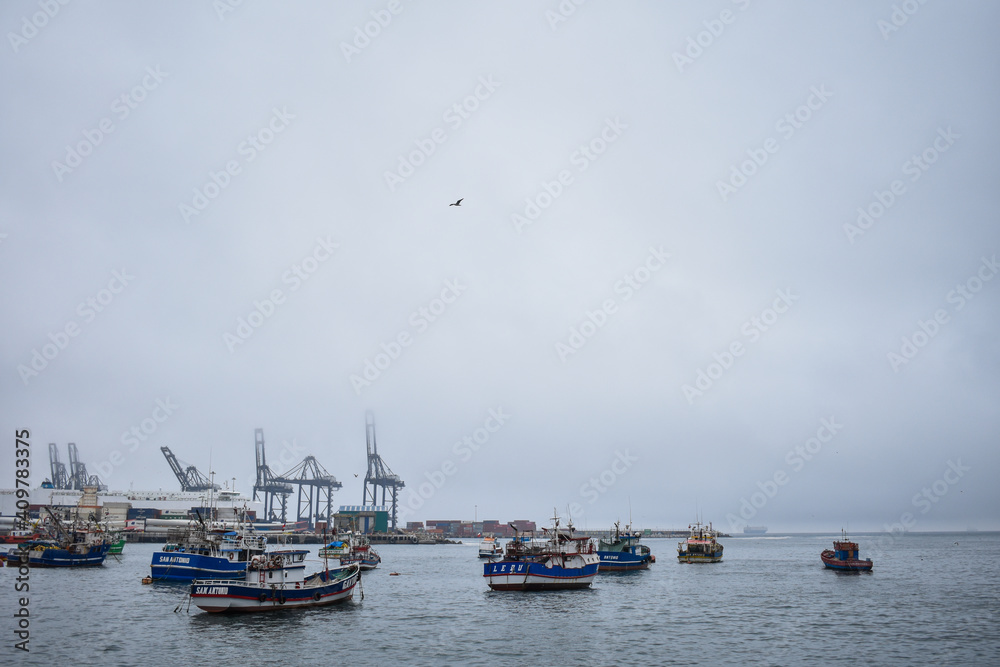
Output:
0 533 1000 666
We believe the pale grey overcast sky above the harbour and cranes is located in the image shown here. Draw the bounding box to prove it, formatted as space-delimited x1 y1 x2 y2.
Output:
0 0 1000 531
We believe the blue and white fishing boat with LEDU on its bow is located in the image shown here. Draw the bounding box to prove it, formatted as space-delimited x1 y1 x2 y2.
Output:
483 516 600 591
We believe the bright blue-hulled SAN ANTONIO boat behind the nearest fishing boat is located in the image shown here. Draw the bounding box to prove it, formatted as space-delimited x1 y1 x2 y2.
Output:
150 517 267 581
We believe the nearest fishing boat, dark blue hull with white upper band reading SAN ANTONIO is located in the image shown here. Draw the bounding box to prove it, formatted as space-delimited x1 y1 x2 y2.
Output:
190 549 361 613
